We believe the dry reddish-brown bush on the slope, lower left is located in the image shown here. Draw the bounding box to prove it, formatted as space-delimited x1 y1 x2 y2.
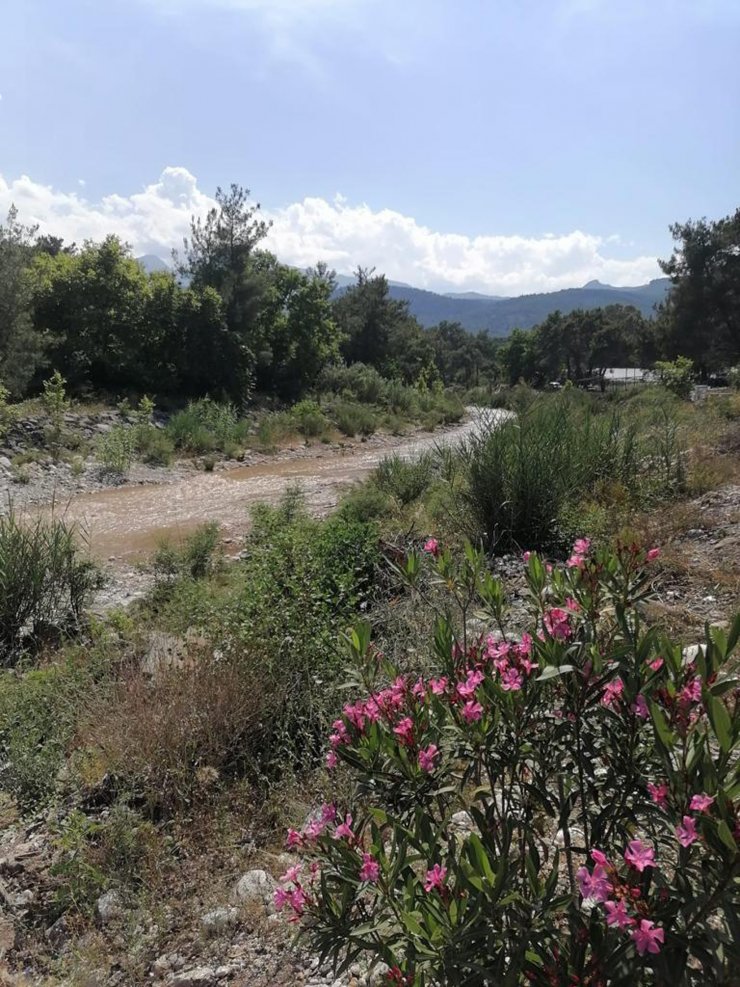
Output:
78 645 276 816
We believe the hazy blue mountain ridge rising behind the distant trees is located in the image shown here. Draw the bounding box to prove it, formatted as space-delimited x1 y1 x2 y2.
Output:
382 278 670 336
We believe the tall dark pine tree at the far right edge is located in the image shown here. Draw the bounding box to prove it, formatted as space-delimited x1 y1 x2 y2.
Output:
660 209 740 374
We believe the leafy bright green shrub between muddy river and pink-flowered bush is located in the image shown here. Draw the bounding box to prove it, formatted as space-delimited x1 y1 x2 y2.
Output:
152 491 379 767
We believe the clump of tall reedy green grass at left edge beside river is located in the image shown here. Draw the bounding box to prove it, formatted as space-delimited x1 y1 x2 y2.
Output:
0 513 100 665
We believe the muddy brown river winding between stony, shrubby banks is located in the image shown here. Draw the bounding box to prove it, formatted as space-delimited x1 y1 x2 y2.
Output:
37 409 494 566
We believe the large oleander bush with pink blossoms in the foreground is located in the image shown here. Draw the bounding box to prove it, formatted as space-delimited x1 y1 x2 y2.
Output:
279 541 740 987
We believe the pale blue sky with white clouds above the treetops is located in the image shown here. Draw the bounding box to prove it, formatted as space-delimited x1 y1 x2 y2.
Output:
0 0 740 295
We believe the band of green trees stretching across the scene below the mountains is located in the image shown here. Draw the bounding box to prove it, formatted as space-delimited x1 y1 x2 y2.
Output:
0 185 740 402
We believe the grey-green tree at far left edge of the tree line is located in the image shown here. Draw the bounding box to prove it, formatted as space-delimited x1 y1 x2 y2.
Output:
0 206 44 397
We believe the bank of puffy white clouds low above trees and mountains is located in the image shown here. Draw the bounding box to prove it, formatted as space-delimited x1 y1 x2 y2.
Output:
0 167 660 295
